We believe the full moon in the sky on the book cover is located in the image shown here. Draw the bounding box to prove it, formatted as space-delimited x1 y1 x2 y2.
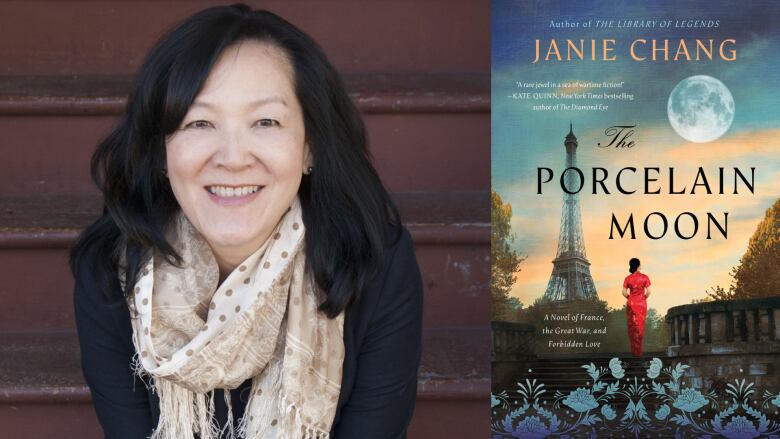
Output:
666 75 734 143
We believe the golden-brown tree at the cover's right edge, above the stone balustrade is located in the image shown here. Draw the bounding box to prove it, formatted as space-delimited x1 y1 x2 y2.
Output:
707 199 780 300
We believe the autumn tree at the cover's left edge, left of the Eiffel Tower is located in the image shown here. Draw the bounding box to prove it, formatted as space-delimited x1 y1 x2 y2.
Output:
490 191 525 320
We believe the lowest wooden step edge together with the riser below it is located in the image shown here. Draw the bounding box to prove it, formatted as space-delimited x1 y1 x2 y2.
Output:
0 326 490 439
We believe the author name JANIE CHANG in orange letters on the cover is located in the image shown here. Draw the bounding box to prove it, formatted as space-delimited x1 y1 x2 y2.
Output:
531 38 737 64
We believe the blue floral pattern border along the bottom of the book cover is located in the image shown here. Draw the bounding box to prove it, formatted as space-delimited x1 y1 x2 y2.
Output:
491 358 780 439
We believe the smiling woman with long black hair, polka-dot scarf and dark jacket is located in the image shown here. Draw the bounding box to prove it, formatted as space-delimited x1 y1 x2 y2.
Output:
71 5 422 439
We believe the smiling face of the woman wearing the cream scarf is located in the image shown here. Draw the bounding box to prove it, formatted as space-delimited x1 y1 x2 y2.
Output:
166 40 310 273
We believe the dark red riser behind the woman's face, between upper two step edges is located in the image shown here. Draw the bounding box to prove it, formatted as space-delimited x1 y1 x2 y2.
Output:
0 106 490 195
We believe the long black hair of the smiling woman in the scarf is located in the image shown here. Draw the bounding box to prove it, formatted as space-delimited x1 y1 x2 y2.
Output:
70 4 401 318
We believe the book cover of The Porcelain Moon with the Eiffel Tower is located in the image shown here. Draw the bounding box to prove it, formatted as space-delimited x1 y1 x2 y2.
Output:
491 0 780 438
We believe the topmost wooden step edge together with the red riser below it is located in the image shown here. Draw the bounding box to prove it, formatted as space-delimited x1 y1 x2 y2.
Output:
0 72 490 195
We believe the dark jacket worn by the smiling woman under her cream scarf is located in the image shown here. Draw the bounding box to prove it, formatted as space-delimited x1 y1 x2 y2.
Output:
74 228 423 439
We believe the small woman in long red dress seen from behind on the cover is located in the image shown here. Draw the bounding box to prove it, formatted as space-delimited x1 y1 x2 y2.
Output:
623 258 650 357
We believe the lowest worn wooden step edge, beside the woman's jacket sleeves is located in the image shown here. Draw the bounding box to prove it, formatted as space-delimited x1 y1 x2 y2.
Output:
0 326 490 404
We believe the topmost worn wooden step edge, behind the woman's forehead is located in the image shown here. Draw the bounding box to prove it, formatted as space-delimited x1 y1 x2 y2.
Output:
0 71 490 116
